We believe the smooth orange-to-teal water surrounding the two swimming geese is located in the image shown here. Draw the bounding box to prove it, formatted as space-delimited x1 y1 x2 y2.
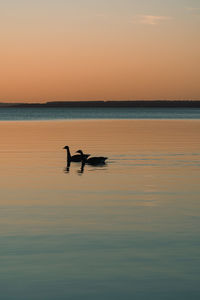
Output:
0 120 200 300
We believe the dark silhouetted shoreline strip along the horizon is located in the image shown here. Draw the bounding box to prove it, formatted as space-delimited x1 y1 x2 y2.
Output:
0 100 200 108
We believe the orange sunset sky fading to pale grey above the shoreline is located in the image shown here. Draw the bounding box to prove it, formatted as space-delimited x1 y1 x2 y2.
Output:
0 0 200 102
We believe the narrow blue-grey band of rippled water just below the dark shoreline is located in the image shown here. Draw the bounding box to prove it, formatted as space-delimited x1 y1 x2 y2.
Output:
0 107 200 121
